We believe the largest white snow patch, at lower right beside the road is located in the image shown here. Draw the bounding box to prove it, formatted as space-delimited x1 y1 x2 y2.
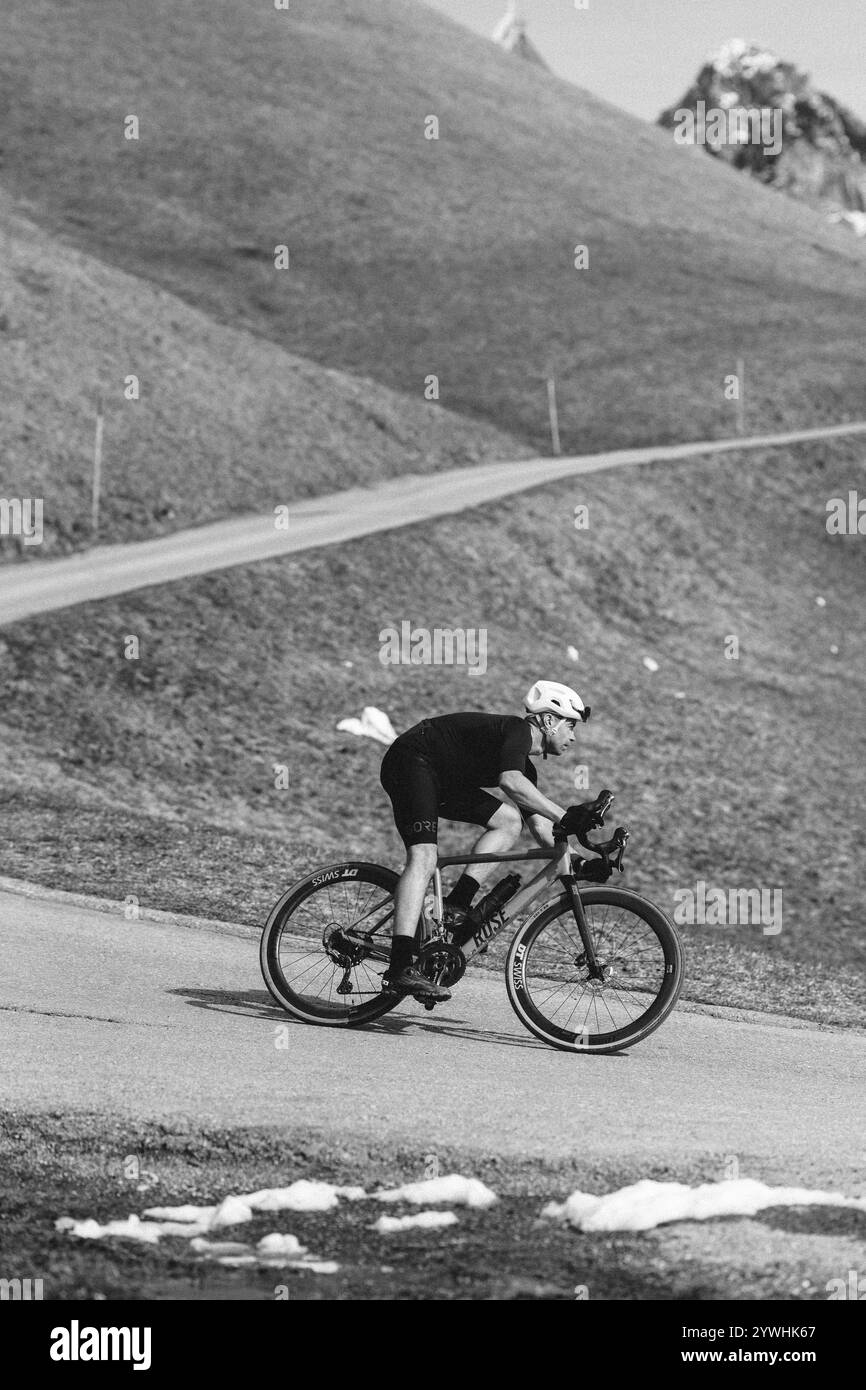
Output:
541 1177 866 1232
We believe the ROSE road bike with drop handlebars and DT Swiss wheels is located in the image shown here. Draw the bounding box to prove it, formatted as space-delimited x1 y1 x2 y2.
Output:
260 791 684 1052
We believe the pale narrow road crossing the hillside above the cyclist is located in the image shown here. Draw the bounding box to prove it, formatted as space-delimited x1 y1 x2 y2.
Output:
0 423 866 627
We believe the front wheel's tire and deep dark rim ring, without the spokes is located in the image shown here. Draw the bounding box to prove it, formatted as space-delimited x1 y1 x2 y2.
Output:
506 887 685 1052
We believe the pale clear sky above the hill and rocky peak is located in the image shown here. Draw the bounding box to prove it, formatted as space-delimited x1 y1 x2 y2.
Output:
418 0 866 121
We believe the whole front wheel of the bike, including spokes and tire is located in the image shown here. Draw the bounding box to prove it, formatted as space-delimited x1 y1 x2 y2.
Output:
506 888 685 1052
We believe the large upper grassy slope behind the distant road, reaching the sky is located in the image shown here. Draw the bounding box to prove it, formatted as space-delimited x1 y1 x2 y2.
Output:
0 0 866 467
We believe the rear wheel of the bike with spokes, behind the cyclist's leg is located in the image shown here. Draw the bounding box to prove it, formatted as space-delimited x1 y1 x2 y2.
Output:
260 860 399 1027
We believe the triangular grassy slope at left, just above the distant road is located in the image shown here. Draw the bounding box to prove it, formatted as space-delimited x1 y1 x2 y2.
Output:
0 196 528 560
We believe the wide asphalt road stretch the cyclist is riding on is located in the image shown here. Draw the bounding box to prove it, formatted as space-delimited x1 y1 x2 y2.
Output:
0 892 866 1193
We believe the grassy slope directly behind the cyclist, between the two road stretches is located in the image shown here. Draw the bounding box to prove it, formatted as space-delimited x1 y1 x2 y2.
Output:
0 441 866 1022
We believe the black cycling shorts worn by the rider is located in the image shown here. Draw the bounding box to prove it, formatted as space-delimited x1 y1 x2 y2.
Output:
379 744 502 848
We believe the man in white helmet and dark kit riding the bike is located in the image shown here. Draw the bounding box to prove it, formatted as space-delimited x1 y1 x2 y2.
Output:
381 681 601 999
